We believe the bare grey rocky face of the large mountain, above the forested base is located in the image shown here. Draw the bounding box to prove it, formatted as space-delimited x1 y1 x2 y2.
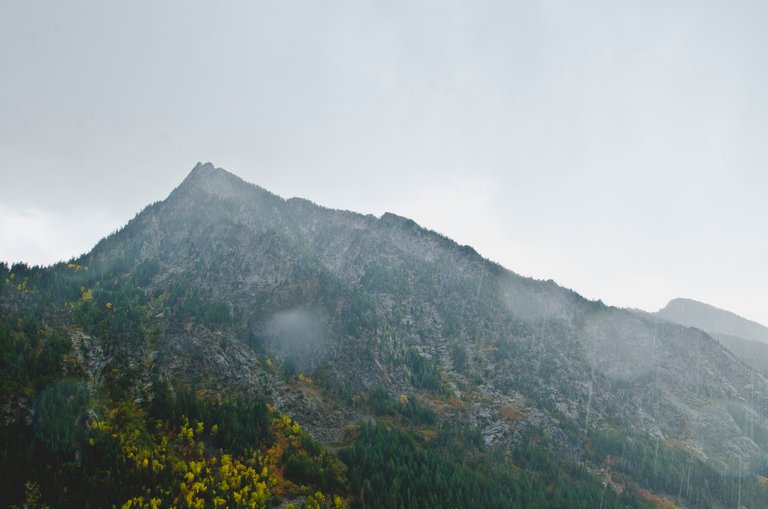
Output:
6 163 768 504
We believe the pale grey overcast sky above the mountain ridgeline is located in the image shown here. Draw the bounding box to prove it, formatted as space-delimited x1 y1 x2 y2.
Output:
0 0 768 324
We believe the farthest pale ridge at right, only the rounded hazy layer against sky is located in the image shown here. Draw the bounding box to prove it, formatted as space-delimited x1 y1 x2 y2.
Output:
656 299 768 344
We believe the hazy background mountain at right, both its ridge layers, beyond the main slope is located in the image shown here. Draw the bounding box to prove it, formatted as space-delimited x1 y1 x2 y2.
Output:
656 299 768 374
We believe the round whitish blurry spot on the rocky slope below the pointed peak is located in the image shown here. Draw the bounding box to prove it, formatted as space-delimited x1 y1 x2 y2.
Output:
265 307 330 373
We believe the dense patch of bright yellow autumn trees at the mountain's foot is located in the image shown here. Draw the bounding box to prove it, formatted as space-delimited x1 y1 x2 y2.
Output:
89 404 347 509
